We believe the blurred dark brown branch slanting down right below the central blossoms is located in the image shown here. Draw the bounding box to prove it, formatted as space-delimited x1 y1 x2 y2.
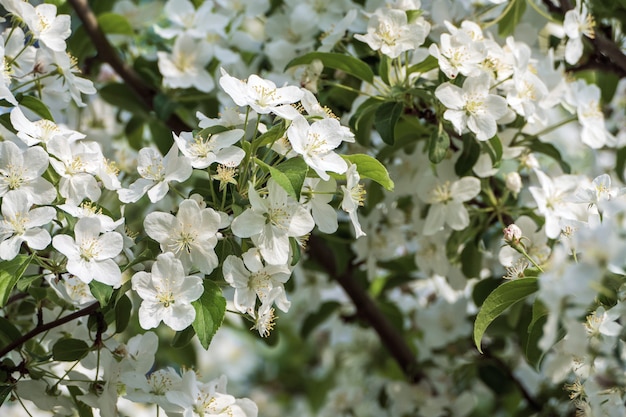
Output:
307 235 424 382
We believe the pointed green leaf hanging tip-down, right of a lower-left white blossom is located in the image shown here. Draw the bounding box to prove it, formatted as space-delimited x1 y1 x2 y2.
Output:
191 280 226 349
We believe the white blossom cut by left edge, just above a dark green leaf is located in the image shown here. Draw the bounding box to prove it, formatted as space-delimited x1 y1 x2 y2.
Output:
0 190 56 260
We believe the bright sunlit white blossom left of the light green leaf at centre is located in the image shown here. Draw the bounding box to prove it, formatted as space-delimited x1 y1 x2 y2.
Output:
287 116 348 181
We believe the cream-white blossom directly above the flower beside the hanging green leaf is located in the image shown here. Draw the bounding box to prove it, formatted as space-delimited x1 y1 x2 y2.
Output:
144 199 220 274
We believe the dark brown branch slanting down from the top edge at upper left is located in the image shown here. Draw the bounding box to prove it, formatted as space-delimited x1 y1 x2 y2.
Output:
68 0 190 134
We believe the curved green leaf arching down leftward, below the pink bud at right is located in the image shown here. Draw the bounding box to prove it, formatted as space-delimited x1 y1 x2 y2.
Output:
474 278 539 353
